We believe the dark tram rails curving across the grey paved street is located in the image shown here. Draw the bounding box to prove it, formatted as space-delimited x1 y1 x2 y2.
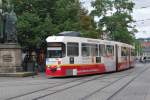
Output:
6 64 146 100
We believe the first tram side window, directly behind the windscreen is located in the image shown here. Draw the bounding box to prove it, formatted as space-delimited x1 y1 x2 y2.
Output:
67 42 79 56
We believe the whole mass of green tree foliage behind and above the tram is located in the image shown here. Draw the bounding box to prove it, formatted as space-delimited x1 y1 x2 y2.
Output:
9 0 136 48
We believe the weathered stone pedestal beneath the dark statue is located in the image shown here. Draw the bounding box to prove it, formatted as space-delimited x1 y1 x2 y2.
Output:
0 43 23 73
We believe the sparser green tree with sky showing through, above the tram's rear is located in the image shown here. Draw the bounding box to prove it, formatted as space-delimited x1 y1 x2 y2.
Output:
91 0 136 44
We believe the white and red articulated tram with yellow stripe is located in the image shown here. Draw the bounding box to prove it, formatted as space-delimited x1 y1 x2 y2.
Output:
46 32 134 77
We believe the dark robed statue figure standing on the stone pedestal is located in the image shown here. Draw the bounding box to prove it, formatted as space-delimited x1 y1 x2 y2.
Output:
0 0 17 43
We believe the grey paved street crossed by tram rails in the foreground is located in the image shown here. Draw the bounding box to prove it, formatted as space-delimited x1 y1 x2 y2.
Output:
0 64 150 100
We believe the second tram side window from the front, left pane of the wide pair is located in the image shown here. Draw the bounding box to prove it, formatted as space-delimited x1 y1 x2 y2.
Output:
82 43 90 57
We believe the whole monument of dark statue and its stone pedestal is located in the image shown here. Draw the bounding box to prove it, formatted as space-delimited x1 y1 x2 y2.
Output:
0 0 22 73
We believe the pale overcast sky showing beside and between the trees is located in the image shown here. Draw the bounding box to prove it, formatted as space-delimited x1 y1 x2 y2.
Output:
81 0 150 38
